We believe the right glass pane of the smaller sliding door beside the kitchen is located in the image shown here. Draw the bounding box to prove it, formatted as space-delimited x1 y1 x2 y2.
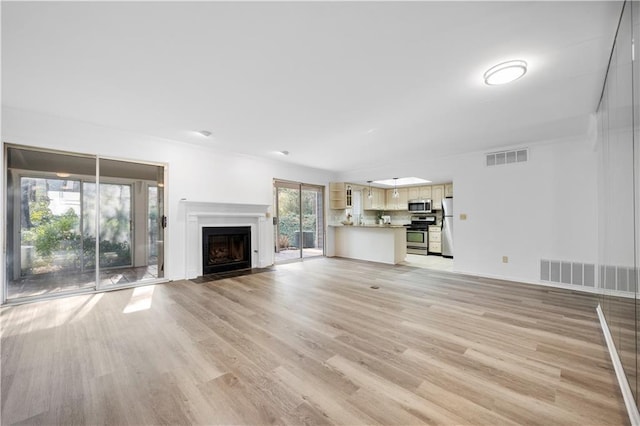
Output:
302 185 324 257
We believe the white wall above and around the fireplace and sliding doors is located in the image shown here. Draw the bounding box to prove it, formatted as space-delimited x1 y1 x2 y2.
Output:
0 108 332 287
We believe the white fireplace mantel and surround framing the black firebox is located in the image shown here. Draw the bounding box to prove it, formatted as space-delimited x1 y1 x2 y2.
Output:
180 200 273 279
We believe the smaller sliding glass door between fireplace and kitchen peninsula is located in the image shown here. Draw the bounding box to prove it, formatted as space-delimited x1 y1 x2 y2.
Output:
273 180 324 262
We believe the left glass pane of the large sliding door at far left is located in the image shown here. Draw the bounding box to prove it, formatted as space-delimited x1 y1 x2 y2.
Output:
6 147 95 300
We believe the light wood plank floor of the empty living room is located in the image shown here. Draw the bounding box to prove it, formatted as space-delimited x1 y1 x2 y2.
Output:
1 258 628 425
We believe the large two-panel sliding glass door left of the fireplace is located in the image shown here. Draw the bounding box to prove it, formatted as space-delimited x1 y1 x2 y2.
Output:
4 146 164 301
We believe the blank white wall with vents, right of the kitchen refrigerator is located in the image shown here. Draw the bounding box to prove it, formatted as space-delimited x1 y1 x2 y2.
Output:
340 137 598 283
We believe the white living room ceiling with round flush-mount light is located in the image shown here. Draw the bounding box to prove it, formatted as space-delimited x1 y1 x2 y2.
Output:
2 1 621 179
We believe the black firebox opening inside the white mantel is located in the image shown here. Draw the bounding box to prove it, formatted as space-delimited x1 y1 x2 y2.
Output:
202 226 251 275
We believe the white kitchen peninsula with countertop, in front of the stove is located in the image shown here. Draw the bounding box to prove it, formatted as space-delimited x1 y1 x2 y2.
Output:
329 225 407 265
